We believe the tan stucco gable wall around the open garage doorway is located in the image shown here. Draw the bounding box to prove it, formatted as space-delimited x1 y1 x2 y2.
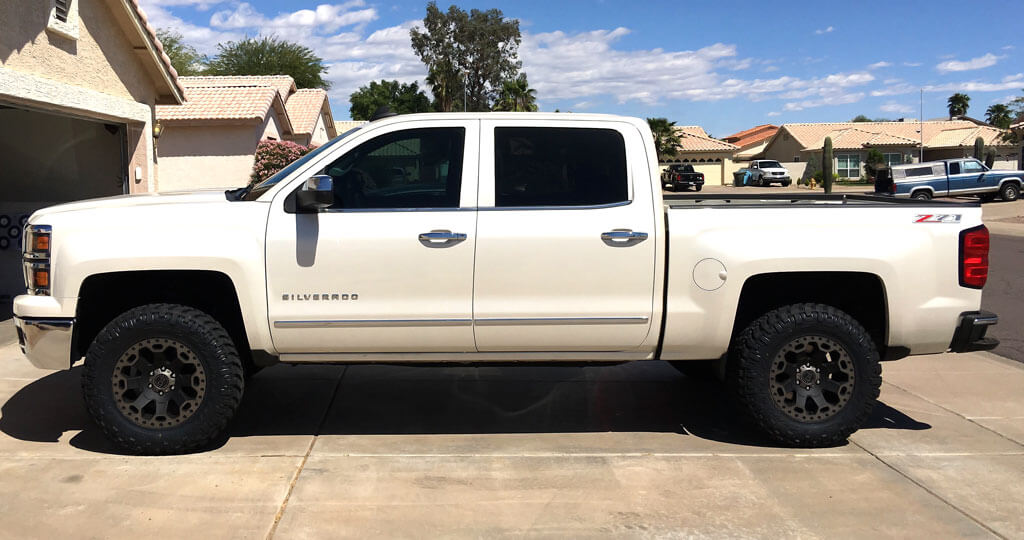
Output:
0 0 158 192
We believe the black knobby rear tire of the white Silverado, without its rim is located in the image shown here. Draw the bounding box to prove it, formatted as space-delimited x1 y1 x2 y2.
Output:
726 303 882 448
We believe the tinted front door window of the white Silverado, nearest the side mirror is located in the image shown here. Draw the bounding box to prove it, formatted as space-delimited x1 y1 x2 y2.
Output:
321 127 466 209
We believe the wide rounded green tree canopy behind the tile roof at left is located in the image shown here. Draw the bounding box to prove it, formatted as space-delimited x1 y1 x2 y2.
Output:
206 36 331 89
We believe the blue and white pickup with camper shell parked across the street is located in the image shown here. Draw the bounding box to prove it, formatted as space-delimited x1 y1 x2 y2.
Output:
876 158 1024 201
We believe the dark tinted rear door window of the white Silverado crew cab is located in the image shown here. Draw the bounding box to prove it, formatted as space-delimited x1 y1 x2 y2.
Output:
495 127 629 207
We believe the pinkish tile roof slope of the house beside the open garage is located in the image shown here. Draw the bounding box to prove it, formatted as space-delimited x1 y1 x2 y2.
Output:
157 86 280 121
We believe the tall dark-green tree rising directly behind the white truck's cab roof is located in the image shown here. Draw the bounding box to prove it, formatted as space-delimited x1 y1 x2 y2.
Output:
410 2 522 112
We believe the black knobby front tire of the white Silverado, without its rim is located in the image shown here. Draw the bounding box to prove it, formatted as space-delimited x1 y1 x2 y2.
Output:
82 304 245 455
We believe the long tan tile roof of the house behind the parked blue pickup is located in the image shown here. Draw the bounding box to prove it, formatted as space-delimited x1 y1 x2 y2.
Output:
782 120 1006 150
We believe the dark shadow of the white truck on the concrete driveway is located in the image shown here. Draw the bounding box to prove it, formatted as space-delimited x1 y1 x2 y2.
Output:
0 362 931 453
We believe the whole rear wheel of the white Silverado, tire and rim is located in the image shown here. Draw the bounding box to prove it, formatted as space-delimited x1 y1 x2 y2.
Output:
728 303 882 447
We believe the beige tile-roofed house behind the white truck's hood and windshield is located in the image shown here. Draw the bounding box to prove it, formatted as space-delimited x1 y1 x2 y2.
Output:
157 75 338 192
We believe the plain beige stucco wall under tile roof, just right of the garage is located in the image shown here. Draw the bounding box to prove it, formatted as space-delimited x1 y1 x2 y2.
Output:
158 112 281 192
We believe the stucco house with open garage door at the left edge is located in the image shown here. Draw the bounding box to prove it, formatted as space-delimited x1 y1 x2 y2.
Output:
0 0 184 298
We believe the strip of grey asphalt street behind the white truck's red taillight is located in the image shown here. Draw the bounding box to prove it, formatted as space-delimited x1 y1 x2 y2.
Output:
981 235 1024 362
